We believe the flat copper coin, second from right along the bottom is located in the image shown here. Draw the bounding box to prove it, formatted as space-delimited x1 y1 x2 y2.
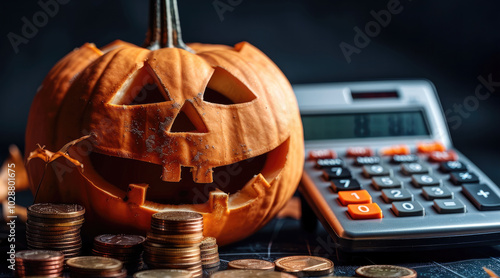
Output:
274 256 333 276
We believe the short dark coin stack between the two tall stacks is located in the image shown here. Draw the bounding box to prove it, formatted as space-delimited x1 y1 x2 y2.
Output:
92 234 146 273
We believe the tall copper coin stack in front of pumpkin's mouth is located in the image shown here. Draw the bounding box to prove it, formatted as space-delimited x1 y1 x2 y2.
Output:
144 211 203 277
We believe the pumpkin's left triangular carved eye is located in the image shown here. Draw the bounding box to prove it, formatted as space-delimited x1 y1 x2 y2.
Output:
111 64 170 105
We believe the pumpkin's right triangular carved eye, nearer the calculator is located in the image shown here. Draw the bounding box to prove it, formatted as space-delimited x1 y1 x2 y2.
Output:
203 67 257 105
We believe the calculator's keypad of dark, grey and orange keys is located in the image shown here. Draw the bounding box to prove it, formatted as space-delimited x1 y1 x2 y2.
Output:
306 144 500 225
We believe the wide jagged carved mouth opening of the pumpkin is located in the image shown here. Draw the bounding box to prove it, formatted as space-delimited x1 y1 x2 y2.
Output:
85 139 289 206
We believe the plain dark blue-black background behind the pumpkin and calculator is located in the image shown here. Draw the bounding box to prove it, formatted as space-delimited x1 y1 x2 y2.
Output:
0 0 500 184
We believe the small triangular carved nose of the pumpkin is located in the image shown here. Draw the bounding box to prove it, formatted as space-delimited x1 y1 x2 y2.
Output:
170 101 208 133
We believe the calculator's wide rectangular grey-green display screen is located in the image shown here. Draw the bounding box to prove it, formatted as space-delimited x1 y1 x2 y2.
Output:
302 111 430 140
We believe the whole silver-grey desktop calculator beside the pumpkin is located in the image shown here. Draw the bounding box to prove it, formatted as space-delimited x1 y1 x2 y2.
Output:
294 80 500 252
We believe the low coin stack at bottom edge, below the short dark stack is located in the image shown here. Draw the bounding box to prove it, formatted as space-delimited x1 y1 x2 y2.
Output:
66 256 127 278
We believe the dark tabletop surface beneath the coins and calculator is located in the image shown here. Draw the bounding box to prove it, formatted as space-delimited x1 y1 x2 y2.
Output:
0 193 500 278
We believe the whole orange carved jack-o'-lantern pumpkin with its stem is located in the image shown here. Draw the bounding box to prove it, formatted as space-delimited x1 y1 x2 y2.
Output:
26 0 304 244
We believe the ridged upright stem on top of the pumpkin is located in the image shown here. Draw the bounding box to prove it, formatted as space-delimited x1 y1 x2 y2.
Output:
144 0 194 52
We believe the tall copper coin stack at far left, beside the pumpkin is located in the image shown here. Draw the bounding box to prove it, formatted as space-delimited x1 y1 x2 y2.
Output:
26 203 85 259
